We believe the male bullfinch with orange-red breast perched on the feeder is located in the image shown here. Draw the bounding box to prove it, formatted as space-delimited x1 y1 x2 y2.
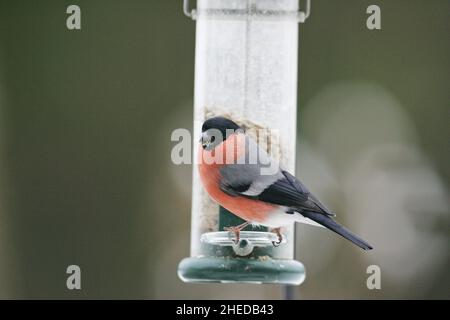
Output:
198 117 372 250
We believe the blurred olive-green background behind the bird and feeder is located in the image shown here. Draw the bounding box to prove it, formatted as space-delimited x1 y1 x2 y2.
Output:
0 0 450 299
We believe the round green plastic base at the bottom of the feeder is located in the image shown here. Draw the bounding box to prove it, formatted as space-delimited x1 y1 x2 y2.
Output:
178 257 305 285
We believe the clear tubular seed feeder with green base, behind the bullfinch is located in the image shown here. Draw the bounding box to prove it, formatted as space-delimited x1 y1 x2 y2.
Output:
178 0 309 285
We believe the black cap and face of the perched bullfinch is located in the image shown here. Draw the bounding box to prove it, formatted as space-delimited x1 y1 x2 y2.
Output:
200 117 244 150
